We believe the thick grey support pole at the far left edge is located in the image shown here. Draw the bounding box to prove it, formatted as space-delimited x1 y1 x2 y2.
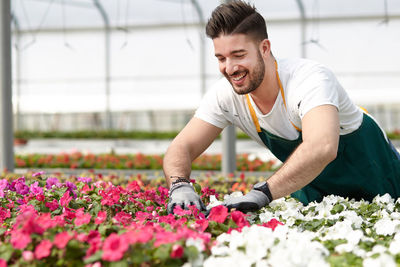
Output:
0 0 14 172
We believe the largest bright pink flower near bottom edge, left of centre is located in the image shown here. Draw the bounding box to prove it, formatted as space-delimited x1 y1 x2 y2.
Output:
101 233 129 261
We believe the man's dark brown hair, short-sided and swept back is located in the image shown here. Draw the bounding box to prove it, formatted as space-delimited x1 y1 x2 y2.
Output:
206 1 268 41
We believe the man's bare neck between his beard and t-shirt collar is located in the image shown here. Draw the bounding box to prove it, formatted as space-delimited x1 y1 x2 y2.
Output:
250 57 280 114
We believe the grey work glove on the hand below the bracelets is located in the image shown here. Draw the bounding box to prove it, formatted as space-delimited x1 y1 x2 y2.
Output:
167 183 206 214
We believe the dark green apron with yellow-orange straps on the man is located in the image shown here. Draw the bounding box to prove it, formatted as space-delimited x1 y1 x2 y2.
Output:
246 61 400 205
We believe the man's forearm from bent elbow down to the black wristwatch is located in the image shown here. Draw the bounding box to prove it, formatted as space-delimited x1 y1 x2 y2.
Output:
268 143 336 199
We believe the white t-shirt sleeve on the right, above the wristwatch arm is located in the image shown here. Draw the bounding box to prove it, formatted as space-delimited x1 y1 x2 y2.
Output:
290 66 339 119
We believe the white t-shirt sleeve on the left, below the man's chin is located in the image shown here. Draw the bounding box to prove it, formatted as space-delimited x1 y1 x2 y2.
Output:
194 82 232 129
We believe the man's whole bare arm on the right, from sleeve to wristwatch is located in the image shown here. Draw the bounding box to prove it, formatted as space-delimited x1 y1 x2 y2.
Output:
268 105 339 199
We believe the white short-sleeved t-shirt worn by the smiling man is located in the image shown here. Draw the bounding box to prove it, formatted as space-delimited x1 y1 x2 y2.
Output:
194 59 363 148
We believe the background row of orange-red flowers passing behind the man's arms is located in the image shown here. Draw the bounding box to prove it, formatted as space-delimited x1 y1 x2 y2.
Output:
15 152 277 171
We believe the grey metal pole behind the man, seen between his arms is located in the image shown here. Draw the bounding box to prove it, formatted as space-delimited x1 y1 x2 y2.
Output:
221 0 236 175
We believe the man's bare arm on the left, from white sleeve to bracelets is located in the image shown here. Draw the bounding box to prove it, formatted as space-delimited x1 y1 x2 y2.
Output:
163 118 222 187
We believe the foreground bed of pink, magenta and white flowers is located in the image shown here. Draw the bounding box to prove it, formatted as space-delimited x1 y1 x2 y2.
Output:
0 173 400 266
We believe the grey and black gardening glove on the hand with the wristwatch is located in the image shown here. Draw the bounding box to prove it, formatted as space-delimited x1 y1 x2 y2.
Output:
223 182 272 213
